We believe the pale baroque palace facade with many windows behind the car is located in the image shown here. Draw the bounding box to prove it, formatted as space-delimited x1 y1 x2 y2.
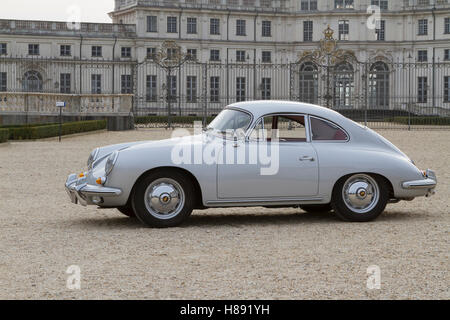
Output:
0 0 450 118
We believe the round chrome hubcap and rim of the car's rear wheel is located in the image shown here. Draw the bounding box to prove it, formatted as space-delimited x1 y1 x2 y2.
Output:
342 174 380 213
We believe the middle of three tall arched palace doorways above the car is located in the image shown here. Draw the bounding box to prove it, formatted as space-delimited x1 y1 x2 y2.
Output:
333 62 355 109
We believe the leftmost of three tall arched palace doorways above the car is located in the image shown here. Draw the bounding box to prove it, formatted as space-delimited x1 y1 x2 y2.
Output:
299 62 319 104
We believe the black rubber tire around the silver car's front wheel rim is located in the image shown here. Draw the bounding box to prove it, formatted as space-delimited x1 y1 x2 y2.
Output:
131 170 195 228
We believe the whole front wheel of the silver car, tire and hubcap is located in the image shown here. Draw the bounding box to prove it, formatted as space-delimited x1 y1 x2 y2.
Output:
132 171 194 228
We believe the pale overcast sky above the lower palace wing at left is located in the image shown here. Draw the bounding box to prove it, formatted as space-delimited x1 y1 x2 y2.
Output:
0 0 114 22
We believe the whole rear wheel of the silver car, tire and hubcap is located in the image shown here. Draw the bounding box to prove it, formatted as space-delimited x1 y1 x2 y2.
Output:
332 174 389 222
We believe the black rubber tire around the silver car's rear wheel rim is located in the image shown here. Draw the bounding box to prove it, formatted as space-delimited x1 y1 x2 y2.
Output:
331 174 389 222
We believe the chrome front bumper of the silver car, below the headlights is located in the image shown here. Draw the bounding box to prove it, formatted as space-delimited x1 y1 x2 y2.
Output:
66 174 122 206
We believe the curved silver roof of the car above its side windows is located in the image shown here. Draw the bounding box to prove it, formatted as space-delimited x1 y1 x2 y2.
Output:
227 100 348 125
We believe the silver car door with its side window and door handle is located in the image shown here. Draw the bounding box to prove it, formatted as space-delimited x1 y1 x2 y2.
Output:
217 115 319 199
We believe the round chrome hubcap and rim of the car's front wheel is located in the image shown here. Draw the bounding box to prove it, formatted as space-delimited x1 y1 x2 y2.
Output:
145 178 185 219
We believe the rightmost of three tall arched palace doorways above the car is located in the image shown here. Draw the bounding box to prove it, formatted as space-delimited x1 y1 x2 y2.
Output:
369 61 390 109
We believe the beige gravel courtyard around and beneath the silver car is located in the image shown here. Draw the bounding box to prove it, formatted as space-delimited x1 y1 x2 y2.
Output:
0 129 450 299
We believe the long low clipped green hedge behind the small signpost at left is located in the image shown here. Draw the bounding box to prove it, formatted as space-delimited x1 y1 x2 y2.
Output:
8 120 106 140
